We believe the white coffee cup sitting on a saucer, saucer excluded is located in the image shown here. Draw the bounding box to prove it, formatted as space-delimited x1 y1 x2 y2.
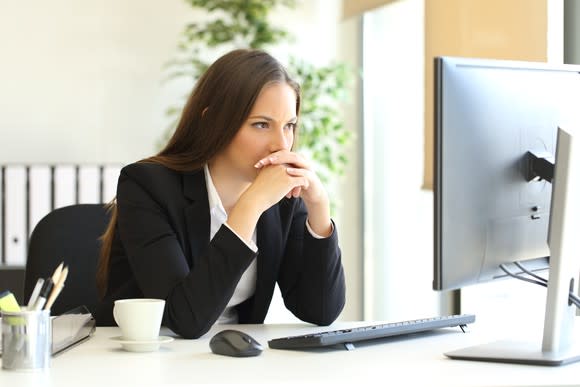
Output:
113 298 165 341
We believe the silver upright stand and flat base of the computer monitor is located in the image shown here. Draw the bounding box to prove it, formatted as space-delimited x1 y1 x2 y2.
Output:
445 128 580 366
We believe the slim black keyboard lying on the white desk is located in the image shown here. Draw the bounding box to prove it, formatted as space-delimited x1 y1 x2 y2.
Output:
268 314 475 349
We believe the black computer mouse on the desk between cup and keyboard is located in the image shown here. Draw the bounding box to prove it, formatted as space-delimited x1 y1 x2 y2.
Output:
209 329 263 357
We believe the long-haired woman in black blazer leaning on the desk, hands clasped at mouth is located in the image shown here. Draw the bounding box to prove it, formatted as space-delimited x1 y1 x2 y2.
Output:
96 50 345 338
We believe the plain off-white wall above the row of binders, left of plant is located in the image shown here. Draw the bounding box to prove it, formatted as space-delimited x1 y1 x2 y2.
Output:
0 0 197 162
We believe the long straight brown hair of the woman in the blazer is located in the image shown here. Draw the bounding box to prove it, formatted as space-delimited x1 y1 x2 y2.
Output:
97 49 300 297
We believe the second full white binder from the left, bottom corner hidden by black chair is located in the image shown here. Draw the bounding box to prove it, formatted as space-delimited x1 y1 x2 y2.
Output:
28 165 52 234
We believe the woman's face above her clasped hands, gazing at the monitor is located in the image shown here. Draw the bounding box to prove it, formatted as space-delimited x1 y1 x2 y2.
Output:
216 83 297 182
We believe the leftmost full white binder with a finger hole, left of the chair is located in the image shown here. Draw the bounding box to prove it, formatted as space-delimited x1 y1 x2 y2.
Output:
4 165 28 266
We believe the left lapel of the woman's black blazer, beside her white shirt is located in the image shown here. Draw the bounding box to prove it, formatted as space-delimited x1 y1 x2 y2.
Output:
183 169 210 265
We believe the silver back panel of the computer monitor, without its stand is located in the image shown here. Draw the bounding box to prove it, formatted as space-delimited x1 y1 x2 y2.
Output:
433 57 580 290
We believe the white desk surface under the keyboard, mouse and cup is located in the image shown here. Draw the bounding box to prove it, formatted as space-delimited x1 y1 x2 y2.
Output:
0 322 580 387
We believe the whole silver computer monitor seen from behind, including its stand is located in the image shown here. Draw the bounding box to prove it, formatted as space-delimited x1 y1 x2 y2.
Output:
433 57 580 365
